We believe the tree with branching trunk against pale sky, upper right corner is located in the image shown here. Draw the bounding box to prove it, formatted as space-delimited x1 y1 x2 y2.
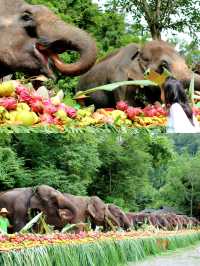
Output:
109 0 200 39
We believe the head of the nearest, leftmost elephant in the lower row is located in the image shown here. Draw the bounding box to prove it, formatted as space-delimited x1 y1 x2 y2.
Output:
30 185 77 229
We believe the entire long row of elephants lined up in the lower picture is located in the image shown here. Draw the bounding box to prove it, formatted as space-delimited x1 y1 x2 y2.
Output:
0 185 199 232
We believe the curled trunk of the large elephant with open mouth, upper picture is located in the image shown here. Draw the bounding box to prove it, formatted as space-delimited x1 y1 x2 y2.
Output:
37 17 97 76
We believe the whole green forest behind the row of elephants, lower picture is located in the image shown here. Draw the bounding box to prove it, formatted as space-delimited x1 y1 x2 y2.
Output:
0 132 200 218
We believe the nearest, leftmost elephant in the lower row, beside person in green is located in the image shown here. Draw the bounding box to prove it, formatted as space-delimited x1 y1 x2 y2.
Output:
0 185 77 232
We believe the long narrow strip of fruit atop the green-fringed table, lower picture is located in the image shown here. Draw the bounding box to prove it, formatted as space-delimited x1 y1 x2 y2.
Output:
0 230 197 252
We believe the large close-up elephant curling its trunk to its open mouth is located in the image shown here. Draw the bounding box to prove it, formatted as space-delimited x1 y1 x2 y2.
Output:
0 0 97 78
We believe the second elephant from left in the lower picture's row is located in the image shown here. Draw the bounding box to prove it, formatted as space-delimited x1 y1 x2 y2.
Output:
63 193 120 229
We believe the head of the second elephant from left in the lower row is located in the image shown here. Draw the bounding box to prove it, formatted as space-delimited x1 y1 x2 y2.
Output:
87 196 120 227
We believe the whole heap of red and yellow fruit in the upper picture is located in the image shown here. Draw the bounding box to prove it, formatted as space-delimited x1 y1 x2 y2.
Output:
0 81 169 127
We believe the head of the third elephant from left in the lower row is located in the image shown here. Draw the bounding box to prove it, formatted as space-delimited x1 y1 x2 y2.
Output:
108 204 131 230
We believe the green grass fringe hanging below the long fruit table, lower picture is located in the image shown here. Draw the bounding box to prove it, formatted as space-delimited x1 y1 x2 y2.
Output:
0 232 200 266
